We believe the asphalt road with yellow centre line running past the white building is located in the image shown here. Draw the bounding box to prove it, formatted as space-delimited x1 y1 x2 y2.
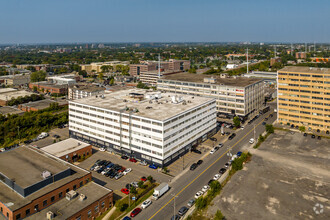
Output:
135 103 276 220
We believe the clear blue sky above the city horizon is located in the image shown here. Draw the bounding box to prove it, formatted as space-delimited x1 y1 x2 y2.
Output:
0 0 330 44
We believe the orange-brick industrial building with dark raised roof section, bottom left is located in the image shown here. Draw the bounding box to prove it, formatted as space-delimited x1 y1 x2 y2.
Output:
0 147 113 220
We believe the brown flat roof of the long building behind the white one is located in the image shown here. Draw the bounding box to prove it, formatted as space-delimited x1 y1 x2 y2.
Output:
161 73 262 87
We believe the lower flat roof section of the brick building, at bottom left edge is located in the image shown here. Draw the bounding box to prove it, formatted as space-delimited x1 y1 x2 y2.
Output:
27 182 112 220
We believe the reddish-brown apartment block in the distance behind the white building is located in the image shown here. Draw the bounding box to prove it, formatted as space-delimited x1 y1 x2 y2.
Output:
130 59 190 76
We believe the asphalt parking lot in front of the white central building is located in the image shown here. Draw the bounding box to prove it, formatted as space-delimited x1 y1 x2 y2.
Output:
78 150 172 199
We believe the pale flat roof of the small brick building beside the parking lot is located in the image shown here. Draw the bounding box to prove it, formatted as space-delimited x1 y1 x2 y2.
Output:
42 138 90 157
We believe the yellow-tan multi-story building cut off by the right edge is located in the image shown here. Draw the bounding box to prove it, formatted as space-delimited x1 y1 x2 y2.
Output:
277 66 330 131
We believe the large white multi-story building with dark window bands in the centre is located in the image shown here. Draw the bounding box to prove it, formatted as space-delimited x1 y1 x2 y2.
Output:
69 89 216 166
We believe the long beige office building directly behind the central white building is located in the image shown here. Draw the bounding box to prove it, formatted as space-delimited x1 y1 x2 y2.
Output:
157 73 265 117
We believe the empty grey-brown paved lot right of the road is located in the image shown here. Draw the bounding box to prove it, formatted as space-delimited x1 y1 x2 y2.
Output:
208 130 330 219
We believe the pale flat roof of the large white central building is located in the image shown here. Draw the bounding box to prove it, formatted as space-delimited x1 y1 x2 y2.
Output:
70 89 214 121
